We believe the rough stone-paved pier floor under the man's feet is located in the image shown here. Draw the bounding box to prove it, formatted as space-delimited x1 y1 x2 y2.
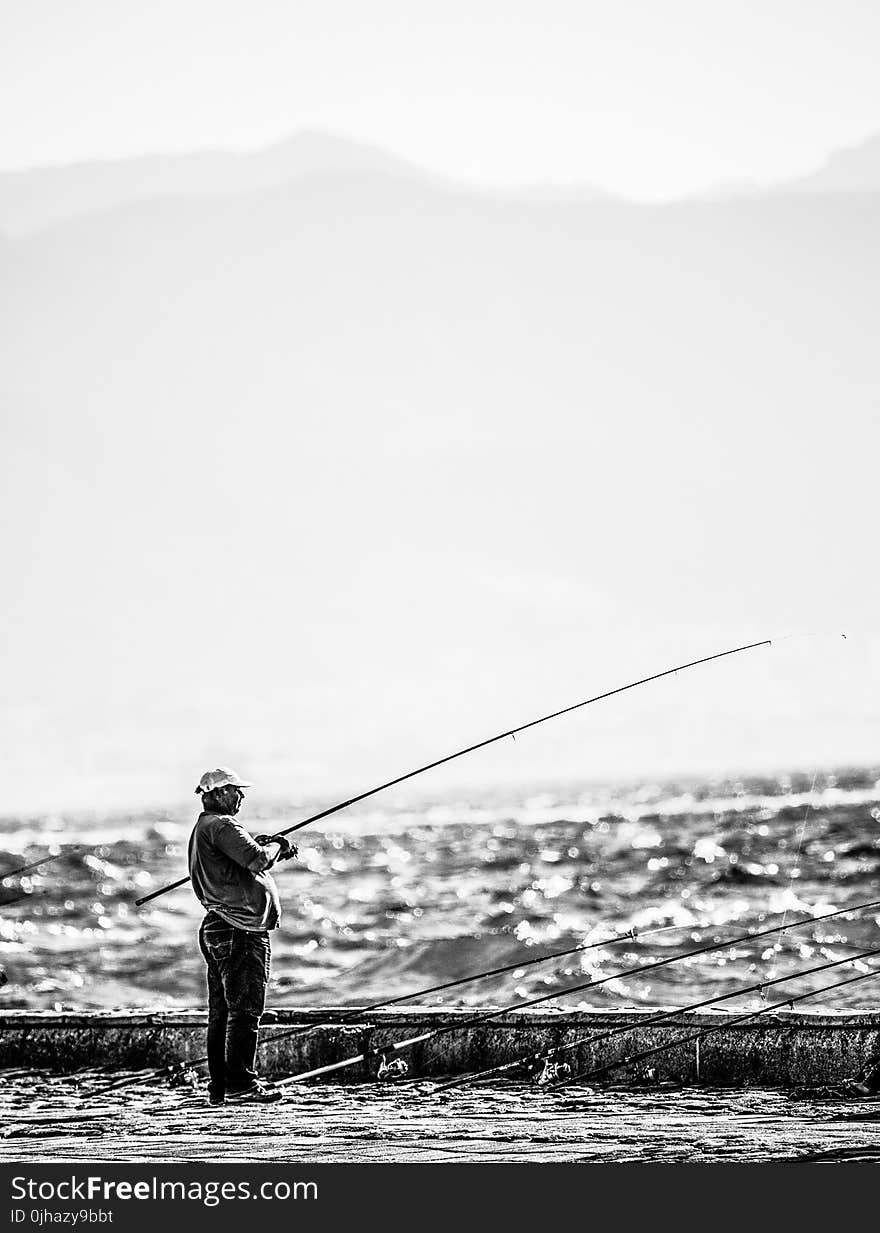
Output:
0 1071 880 1164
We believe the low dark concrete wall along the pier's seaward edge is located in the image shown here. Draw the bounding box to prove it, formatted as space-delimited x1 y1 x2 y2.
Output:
0 1006 880 1088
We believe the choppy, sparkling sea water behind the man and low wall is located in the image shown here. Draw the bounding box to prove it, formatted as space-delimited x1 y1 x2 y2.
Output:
0 768 880 1010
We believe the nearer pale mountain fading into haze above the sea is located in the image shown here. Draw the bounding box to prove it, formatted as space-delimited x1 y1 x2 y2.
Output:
0 141 880 808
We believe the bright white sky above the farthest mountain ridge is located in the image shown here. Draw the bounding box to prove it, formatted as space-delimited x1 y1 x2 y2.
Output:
0 0 880 197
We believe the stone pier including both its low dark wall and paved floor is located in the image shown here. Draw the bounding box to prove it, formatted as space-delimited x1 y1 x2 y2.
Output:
0 1007 880 1163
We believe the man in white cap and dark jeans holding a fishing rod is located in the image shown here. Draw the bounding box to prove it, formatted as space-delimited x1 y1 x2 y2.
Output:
190 767 297 1105
